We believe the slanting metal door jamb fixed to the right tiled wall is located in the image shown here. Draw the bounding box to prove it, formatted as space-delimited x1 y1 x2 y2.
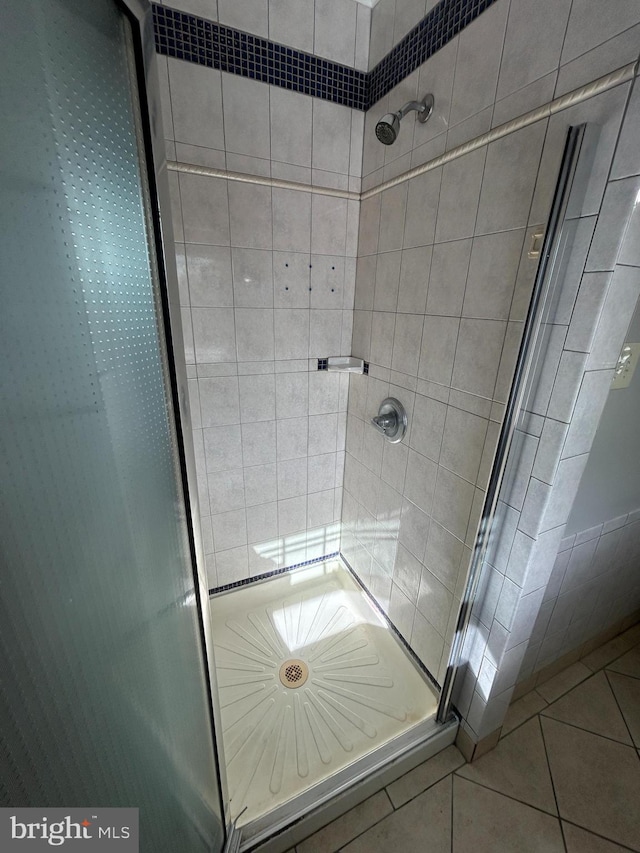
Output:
436 124 587 723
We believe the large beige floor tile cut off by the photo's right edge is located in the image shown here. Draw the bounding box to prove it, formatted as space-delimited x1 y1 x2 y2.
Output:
541 717 640 850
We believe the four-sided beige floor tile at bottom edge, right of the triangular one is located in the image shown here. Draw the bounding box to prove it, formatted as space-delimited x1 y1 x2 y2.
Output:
452 775 564 853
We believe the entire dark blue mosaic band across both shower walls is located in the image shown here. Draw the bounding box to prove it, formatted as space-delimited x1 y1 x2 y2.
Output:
153 0 495 110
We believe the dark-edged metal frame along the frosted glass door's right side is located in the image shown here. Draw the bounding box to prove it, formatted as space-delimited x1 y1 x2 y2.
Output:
116 0 230 850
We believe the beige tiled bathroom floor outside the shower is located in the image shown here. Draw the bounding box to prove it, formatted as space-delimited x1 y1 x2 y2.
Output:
290 625 640 853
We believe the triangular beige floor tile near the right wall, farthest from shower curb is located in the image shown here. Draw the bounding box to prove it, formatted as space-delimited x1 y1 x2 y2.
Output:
542 671 640 746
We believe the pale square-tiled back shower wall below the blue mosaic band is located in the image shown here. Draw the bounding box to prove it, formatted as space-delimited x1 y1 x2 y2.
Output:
161 59 363 588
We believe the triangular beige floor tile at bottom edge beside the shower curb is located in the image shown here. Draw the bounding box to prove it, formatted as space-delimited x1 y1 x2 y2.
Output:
342 776 452 853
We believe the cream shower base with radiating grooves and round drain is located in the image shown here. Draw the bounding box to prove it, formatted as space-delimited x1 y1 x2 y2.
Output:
211 560 438 826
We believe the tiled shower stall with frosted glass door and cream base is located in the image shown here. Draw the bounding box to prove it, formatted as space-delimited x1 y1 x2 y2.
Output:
0 0 640 851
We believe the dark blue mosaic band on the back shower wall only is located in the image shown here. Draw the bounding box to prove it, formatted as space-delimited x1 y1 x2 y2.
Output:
153 5 367 110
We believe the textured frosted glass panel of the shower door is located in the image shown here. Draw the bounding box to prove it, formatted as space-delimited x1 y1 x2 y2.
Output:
0 0 222 853
